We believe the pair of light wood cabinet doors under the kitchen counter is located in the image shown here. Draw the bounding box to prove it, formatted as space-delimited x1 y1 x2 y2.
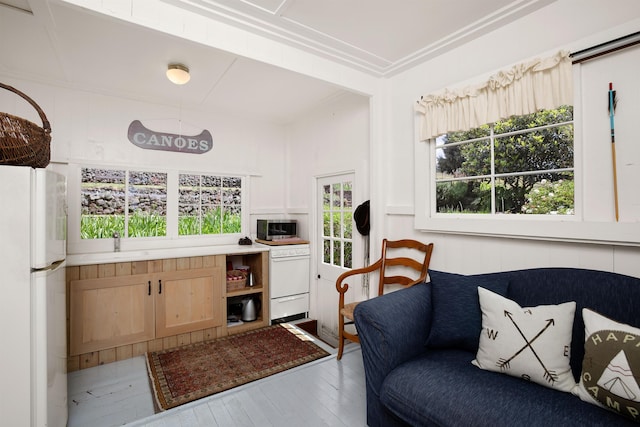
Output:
69 267 224 355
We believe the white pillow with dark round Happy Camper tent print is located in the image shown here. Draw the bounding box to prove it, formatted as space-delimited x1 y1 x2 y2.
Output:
573 308 640 422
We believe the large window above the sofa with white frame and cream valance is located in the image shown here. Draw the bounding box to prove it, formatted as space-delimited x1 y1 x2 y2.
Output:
413 45 640 247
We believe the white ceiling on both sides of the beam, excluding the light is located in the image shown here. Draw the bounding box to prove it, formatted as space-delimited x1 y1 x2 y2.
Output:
0 0 553 124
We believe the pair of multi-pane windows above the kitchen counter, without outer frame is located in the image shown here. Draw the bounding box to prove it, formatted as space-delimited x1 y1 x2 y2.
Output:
80 167 243 240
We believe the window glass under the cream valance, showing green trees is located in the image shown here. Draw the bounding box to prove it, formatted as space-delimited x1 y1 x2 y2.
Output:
432 106 575 215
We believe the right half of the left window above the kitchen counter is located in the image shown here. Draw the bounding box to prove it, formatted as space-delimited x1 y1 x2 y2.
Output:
128 171 167 237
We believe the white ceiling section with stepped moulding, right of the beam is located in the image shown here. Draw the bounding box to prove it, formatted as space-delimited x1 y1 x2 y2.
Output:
169 0 554 75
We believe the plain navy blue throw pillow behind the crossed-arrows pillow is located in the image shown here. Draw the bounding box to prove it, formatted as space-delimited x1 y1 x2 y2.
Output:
426 270 509 351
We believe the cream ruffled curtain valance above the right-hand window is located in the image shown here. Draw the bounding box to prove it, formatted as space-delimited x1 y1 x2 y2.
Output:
415 51 573 141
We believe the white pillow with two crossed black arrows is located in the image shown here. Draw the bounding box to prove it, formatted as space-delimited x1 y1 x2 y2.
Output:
472 287 576 392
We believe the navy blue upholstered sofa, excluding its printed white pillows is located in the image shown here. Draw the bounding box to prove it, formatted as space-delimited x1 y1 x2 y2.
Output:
354 268 640 427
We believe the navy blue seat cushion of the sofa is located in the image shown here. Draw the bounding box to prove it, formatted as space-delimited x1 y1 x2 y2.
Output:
380 350 635 427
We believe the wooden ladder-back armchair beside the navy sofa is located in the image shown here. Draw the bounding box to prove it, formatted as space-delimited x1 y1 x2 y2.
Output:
336 239 433 360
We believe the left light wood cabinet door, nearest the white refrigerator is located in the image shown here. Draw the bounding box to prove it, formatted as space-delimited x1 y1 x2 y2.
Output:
69 274 154 355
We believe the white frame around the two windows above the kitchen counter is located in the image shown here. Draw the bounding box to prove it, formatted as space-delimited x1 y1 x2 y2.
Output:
67 163 250 255
